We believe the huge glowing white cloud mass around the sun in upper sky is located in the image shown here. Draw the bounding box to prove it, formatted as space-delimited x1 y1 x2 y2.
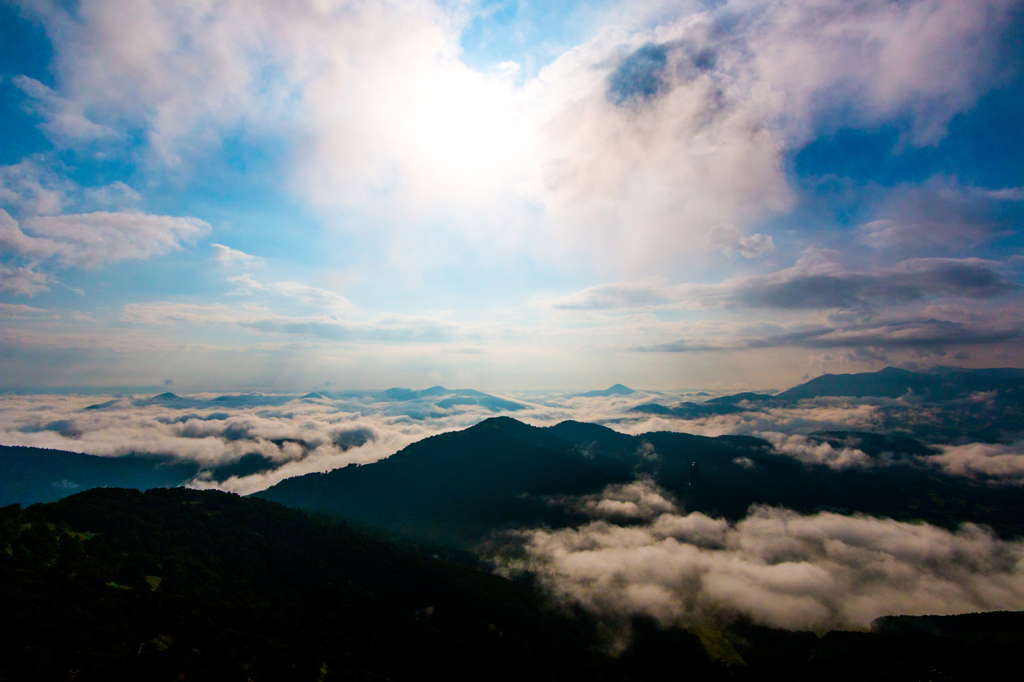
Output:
18 0 1013 271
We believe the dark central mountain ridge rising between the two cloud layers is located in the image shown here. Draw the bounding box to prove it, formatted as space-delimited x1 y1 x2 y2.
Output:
257 417 1024 545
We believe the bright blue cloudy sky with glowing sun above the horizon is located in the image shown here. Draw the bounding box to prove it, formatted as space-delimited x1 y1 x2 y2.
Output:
0 0 1024 392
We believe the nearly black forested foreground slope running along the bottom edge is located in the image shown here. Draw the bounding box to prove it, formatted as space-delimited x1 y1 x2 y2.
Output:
6 488 1024 682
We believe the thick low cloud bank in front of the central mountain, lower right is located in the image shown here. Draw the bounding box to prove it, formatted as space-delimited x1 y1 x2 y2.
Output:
497 481 1024 632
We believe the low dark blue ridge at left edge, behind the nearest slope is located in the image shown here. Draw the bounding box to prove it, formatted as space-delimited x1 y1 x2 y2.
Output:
0 445 199 506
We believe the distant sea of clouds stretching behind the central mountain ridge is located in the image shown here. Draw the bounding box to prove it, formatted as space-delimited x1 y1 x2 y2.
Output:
0 382 1024 494
